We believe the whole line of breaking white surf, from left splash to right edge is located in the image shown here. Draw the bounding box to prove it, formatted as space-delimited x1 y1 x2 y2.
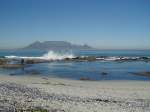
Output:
5 51 150 61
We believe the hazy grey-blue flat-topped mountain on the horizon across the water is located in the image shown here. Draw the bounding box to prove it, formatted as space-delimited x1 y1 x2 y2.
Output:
23 41 94 50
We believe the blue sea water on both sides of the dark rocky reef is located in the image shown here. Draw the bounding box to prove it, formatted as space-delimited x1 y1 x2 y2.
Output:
0 50 150 80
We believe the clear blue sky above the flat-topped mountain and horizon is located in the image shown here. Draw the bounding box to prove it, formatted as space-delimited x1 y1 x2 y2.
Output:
0 0 150 49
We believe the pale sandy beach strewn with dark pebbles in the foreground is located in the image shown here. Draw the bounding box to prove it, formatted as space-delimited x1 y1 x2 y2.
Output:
0 75 150 112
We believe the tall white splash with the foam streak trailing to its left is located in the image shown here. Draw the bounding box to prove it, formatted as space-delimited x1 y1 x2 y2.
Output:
5 51 75 60
